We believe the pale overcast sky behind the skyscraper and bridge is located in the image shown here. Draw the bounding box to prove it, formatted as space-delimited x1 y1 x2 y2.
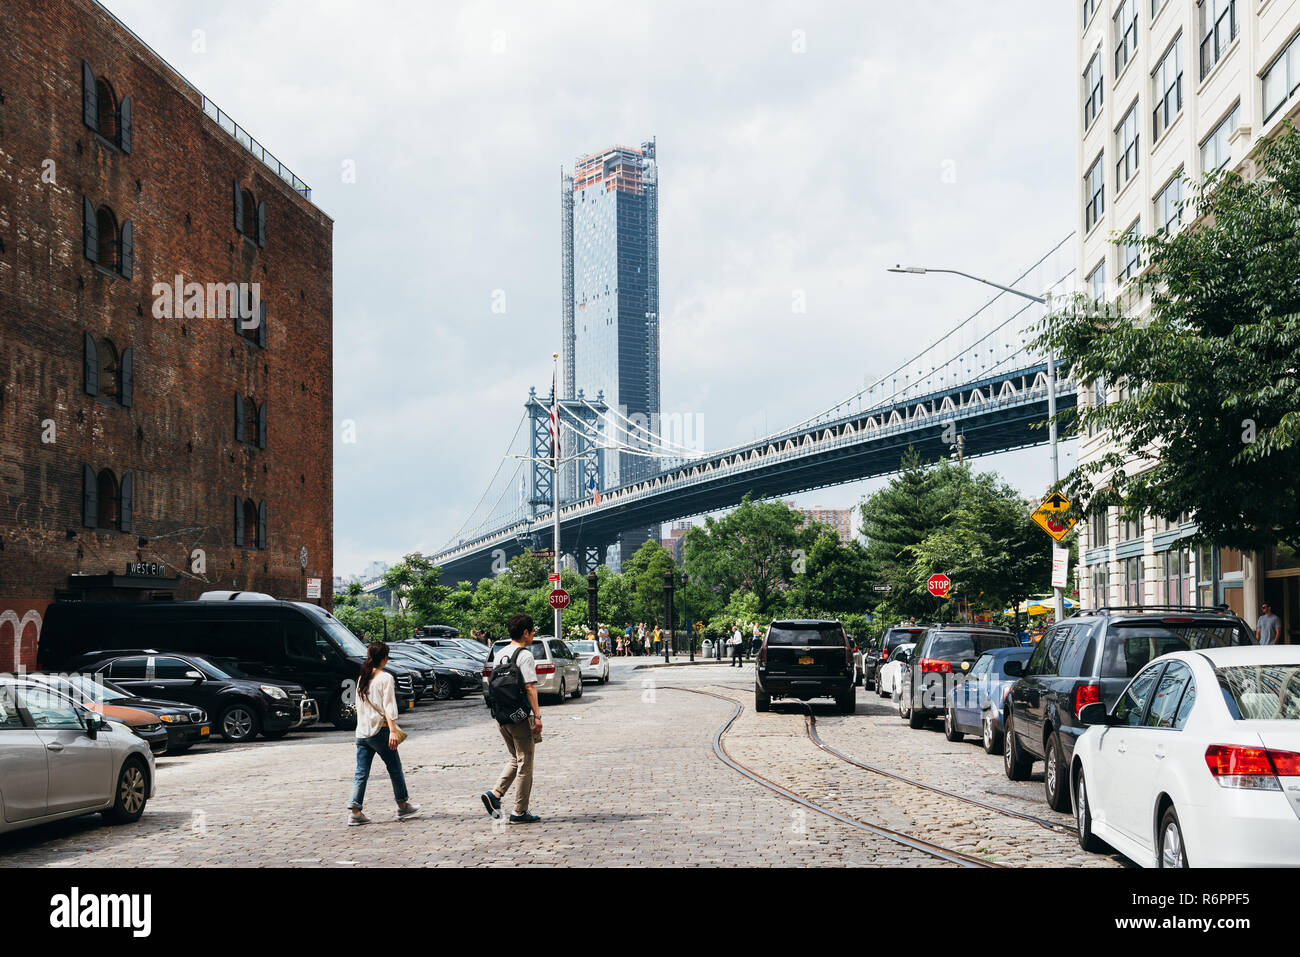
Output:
98 0 1079 573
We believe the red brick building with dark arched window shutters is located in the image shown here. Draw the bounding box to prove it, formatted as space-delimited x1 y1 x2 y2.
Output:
0 0 333 671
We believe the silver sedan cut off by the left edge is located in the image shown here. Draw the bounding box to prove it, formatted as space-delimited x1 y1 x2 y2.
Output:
0 677 155 833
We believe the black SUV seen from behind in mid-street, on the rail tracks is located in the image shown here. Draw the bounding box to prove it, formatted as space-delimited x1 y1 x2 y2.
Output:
754 619 858 714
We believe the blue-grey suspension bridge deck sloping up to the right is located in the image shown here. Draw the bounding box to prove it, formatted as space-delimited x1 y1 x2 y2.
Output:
432 365 1078 585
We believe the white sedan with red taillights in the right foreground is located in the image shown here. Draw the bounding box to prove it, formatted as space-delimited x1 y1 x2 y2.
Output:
1070 645 1300 867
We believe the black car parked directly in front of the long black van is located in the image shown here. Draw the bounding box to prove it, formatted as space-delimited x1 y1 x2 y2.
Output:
76 653 306 741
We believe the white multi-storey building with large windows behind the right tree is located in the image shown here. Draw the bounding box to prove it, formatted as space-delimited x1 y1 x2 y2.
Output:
1075 0 1300 642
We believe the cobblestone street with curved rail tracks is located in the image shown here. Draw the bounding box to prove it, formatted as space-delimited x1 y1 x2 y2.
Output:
0 659 1122 867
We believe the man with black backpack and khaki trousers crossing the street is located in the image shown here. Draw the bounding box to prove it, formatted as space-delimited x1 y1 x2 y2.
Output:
482 614 542 824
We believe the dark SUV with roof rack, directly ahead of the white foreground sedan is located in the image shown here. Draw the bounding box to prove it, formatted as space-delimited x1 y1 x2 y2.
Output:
1002 605 1256 811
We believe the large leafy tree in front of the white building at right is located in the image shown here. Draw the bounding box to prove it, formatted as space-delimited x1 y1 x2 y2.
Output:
1039 125 1300 550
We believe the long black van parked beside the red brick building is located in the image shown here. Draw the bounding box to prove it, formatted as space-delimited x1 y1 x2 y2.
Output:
36 592 415 729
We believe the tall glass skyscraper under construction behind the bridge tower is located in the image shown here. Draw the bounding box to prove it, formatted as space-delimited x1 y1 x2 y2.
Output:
560 139 659 563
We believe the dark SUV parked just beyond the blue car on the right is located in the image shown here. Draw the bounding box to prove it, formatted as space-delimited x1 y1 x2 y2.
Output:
898 624 1021 728
